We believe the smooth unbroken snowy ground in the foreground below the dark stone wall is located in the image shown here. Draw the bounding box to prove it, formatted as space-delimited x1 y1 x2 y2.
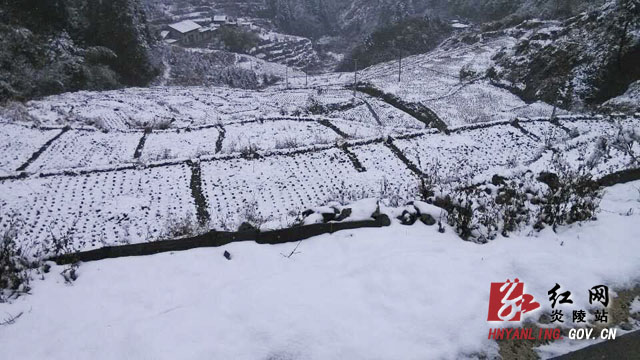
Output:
0 182 640 360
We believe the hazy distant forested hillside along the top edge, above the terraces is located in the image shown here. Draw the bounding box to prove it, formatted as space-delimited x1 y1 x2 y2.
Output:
265 0 604 38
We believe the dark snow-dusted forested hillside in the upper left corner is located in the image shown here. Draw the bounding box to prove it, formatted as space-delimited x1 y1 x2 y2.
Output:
0 0 158 101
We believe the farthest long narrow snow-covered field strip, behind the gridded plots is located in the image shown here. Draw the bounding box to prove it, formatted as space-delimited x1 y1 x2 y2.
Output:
27 87 423 131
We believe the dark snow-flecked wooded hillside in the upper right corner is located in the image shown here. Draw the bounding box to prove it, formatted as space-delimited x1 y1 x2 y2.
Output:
489 0 640 109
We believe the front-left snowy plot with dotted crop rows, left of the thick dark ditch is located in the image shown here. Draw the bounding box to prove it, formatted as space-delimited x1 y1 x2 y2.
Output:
0 164 195 250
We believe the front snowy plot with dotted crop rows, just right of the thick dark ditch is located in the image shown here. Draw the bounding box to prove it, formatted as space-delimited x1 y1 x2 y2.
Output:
201 149 357 229
